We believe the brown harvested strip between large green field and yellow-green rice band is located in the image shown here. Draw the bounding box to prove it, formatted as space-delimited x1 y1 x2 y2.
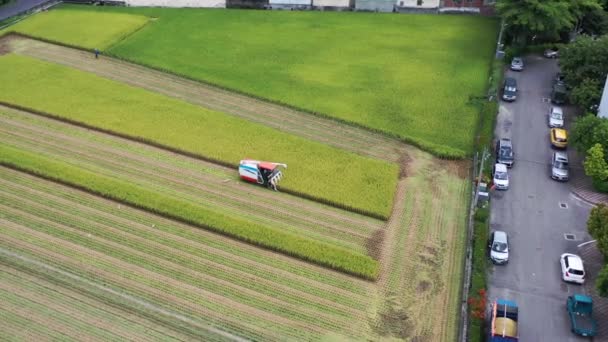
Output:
0 35 409 163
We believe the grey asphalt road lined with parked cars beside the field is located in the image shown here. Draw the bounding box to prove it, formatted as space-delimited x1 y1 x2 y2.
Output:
489 56 591 342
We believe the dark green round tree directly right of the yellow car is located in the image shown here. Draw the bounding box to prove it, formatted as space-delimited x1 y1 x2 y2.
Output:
570 114 608 152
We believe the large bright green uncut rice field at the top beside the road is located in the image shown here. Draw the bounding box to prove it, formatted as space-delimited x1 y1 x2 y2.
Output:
5 6 497 157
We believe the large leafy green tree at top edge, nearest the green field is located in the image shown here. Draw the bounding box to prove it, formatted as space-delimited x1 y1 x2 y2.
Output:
496 0 578 44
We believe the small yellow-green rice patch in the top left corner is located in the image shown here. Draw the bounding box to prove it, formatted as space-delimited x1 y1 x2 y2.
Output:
0 9 149 50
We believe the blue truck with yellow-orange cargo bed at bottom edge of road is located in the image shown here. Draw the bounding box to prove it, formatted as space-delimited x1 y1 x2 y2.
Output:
488 299 519 342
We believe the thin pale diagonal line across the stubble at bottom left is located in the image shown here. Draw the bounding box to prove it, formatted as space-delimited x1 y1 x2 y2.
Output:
0 247 248 342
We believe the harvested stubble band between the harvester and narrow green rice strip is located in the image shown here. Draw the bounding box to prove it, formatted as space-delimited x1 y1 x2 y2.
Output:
0 108 383 253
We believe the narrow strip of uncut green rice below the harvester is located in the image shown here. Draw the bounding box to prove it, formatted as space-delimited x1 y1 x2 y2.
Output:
0 145 378 279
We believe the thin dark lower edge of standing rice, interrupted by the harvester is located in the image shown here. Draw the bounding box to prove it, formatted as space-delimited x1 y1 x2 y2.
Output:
0 101 388 221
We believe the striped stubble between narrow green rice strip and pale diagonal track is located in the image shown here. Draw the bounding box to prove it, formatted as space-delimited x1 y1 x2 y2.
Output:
0 168 372 340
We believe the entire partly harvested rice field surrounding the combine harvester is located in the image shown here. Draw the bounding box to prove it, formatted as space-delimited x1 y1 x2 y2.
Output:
0 6 484 342
